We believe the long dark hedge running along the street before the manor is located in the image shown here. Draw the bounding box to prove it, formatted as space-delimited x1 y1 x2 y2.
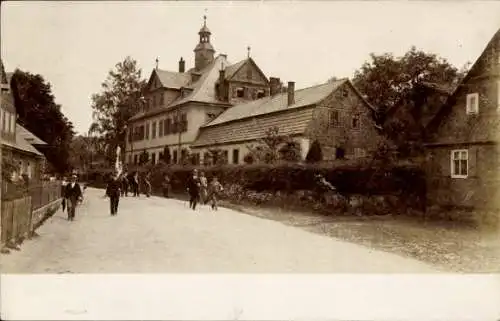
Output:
83 161 425 196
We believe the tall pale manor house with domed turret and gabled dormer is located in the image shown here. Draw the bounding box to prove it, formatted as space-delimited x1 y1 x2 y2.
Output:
125 16 276 164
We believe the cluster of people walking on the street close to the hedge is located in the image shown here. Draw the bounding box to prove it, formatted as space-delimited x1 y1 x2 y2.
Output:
187 169 224 210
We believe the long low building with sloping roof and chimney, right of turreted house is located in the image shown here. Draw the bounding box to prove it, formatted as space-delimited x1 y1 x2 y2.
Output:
192 79 380 164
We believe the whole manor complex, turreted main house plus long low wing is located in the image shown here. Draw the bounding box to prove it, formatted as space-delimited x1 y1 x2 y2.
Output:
125 18 378 164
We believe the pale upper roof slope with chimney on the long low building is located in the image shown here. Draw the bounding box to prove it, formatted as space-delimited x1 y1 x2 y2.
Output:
204 78 348 127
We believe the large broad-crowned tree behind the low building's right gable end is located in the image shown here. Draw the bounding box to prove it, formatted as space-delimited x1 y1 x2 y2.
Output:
354 47 467 156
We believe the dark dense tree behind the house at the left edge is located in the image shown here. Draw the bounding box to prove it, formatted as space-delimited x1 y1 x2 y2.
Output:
11 69 75 174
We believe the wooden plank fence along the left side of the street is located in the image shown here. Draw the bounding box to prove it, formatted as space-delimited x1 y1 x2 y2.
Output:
0 181 61 247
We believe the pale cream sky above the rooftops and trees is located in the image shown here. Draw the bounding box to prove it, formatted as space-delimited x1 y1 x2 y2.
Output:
1 1 500 133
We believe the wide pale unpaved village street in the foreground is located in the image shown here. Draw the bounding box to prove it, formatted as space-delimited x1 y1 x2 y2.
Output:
0 188 436 273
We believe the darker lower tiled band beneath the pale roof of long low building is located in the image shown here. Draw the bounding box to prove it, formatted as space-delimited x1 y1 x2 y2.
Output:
192 107 313 147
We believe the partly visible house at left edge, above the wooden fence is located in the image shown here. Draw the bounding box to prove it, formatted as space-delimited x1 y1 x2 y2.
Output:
0 62 46 181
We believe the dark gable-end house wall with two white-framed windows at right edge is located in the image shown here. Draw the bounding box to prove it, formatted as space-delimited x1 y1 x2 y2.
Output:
426 30 500 210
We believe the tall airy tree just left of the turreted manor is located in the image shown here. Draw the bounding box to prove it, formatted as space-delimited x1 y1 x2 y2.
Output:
92 57 146 161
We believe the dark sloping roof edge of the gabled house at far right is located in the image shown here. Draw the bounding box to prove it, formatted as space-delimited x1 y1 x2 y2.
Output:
428 29 500 131
